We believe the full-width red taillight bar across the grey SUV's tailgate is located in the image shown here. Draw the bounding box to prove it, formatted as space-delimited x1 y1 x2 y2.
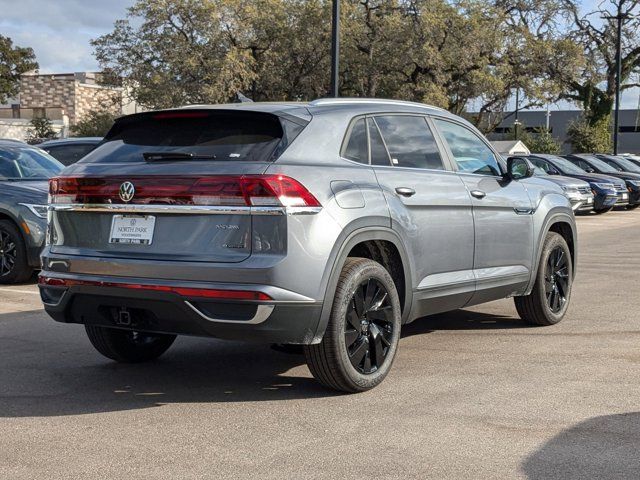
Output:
49 175 321 207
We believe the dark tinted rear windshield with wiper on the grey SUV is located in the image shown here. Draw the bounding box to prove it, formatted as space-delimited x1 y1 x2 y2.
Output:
81 110 305 163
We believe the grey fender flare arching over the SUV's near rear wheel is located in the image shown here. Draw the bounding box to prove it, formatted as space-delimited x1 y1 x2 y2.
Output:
311 226 413 343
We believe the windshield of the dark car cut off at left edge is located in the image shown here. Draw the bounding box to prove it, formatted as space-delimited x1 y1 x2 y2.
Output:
0 146 64 180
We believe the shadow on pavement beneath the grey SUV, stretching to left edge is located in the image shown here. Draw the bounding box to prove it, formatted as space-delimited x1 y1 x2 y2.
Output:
0 310 524 418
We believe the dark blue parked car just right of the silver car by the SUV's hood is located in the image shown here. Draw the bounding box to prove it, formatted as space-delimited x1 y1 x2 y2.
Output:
528 153 629 213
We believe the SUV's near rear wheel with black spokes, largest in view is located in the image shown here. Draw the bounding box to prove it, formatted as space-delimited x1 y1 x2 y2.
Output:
304 258 401 393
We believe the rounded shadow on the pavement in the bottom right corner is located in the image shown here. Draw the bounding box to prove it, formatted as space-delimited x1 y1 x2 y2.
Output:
522 412 640 480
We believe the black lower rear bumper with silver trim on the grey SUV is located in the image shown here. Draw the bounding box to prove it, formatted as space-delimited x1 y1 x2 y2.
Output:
40 272 322 344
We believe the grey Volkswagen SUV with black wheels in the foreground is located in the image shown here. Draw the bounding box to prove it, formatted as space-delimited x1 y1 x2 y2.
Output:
39 99 577 392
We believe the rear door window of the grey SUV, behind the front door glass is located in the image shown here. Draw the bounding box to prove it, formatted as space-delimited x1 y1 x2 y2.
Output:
375 115 444 170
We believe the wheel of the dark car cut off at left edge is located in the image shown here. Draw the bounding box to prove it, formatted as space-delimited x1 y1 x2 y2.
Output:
0 220 33 284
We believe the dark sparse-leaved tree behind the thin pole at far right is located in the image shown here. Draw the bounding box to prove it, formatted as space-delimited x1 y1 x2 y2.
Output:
563 0 640 127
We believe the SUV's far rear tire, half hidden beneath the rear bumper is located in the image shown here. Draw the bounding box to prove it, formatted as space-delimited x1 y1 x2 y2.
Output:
85 325 176 363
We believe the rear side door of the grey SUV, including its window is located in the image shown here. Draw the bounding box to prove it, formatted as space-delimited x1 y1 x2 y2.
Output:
367 114 475 318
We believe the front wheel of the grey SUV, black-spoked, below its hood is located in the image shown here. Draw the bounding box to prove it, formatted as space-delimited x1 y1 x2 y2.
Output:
514 232 573 325
